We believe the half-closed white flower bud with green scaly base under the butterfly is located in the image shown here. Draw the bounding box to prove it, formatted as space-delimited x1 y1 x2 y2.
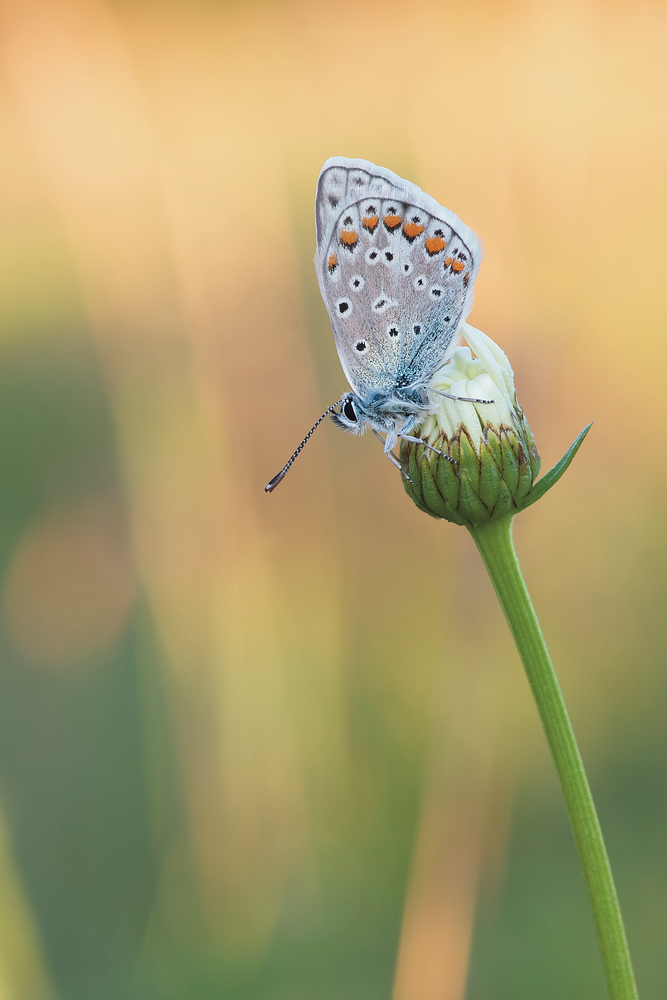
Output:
400 323 540 528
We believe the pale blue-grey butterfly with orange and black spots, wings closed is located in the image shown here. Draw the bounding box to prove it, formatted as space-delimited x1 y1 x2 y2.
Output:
265 156 488 492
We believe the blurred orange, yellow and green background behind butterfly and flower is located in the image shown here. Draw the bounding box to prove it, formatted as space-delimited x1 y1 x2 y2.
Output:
0 0 667 1000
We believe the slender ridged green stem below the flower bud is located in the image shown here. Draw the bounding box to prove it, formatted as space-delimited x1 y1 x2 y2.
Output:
471 516 637 1000
